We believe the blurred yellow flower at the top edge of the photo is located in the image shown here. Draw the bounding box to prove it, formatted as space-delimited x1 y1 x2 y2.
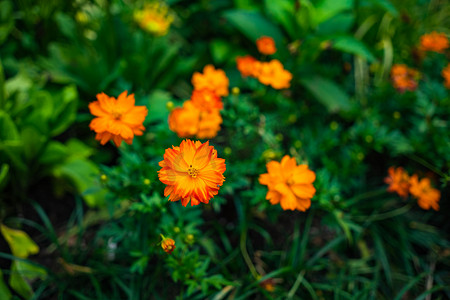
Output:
134 2 173 36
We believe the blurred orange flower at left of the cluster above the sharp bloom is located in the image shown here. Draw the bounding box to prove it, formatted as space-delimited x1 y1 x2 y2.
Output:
169 101 200 137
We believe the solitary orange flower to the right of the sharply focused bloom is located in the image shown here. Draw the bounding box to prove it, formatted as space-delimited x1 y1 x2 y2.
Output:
259 155 316 211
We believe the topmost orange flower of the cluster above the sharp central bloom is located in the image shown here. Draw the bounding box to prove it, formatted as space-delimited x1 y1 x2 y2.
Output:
192 65 230 96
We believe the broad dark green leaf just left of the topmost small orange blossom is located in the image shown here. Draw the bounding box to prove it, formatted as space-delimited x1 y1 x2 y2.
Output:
224 10 283 47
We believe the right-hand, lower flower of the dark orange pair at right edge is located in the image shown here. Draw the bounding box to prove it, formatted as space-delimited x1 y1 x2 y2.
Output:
409 174 441 211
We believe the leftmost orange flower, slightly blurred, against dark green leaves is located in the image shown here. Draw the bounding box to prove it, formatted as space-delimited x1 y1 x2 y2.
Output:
89 91 148 147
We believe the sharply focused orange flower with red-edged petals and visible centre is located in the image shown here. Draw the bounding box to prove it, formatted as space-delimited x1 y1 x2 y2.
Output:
158 140 226 206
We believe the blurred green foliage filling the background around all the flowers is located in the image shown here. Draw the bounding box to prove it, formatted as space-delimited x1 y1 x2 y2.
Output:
0 0 450 300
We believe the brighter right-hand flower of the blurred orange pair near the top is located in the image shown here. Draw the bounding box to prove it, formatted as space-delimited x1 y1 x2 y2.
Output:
253 59 292 90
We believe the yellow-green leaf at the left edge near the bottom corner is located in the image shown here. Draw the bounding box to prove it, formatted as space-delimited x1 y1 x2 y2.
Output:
0 224 39 258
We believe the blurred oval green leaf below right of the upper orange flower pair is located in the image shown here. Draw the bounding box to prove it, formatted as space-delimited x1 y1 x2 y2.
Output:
300 76 351 112
